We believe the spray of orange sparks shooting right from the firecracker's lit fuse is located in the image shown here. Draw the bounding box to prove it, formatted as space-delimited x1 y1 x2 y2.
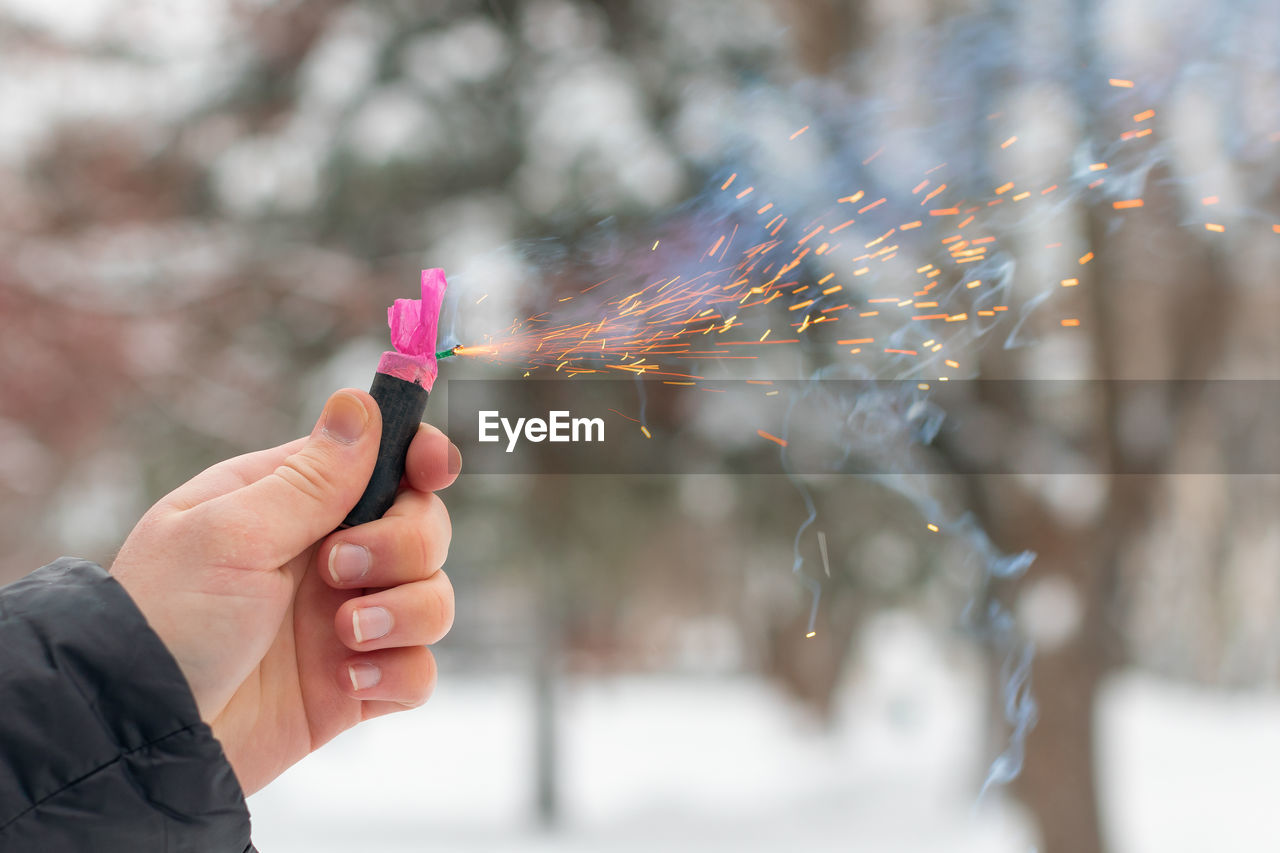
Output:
440 78 1264 382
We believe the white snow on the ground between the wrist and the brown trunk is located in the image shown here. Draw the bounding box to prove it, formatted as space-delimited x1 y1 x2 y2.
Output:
250 617 1032 853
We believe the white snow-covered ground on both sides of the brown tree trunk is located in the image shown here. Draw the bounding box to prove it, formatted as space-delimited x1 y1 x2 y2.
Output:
250 617 1280 853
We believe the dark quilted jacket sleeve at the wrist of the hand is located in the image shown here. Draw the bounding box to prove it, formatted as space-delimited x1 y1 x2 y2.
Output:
0 557 253 853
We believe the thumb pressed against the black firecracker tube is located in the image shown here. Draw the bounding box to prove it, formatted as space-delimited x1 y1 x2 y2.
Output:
204 388 381 569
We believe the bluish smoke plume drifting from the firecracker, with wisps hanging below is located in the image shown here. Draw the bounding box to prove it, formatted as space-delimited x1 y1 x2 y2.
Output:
430 1 1280 794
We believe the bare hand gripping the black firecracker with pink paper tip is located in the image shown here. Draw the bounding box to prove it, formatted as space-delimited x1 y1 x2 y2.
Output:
111 389 461 794
